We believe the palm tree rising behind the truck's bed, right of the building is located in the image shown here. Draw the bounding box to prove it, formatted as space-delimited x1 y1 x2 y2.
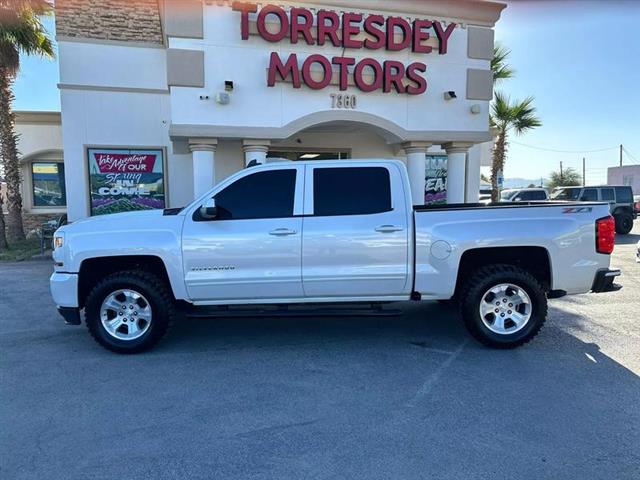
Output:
491 92 542 202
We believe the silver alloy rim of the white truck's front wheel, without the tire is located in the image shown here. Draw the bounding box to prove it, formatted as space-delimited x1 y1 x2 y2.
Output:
100 288 151 340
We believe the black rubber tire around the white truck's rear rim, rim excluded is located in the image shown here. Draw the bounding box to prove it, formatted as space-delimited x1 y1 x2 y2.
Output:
459 264 547 349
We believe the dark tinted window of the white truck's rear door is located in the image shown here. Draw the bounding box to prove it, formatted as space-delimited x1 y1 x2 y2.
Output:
313 167 391 216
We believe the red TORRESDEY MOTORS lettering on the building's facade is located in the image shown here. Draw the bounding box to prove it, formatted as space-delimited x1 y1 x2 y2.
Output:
233 2 456 95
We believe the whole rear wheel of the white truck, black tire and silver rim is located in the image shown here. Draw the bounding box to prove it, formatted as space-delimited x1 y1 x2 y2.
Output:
460 264 547 348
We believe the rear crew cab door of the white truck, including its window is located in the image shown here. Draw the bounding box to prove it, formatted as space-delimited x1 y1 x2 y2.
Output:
302 163 409 298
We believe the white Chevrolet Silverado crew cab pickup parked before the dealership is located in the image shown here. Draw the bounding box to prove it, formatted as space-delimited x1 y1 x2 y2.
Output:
51 160 620 353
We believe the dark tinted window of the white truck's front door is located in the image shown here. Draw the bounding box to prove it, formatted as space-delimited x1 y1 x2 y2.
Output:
215 169 296 220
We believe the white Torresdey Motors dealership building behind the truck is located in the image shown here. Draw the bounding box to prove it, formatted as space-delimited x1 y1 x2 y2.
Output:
11 0 505 221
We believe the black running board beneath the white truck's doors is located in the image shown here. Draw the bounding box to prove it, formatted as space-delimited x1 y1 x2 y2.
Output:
185 306 402 318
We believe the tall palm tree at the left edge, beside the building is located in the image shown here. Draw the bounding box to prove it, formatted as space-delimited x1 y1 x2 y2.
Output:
0 0 54 247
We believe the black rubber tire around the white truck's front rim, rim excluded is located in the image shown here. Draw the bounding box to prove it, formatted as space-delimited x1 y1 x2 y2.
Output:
85 271 175 353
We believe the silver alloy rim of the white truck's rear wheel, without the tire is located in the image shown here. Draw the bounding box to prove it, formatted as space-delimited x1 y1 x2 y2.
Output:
480 283 532 335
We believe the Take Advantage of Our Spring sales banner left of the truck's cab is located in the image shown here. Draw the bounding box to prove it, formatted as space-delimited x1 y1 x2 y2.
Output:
88 148 165 215
